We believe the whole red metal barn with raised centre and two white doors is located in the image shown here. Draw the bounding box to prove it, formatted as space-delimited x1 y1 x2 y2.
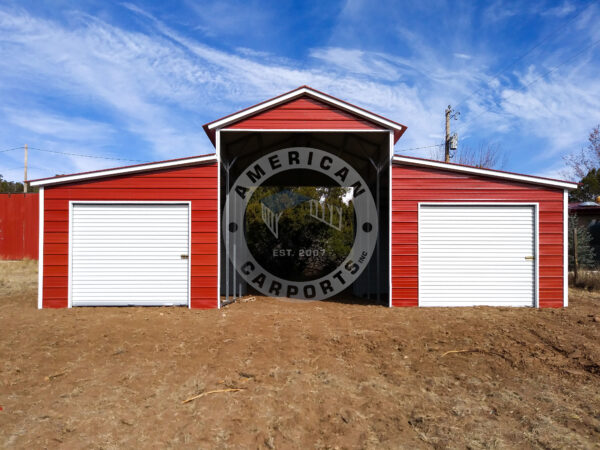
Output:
32 87 576 308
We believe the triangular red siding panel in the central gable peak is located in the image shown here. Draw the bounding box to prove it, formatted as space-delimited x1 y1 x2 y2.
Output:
228 97 382 130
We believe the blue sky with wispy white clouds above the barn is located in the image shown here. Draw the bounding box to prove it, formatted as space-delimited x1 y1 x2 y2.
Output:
0 0 600 180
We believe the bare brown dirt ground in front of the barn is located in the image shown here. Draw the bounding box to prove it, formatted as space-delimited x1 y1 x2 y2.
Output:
0 262 600 449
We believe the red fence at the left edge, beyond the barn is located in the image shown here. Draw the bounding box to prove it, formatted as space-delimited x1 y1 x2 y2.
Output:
0 194 40 259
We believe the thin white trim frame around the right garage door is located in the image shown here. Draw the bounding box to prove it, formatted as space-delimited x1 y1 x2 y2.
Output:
417 204 540 308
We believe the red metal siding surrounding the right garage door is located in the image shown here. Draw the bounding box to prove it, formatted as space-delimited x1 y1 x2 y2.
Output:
391 165 564 308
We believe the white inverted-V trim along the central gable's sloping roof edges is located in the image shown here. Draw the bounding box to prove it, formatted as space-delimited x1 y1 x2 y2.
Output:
208 87 405 131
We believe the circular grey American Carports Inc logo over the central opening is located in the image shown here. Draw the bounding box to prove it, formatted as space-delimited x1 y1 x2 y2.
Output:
222 147 379 300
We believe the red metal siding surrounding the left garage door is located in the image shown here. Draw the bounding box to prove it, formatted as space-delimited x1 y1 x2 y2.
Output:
43 163 219 308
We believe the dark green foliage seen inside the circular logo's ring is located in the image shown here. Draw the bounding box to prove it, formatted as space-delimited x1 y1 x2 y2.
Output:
245 186 355 281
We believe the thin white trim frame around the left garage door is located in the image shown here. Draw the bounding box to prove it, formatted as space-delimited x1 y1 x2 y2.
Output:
68 201 192 308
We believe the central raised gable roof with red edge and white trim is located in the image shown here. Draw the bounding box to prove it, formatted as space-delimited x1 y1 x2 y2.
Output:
203 86 406 145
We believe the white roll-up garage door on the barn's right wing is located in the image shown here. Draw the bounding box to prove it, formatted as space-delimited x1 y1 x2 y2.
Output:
419 205 536 306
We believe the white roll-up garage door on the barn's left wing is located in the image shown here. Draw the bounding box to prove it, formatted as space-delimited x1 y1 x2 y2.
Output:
70 203 189 306
